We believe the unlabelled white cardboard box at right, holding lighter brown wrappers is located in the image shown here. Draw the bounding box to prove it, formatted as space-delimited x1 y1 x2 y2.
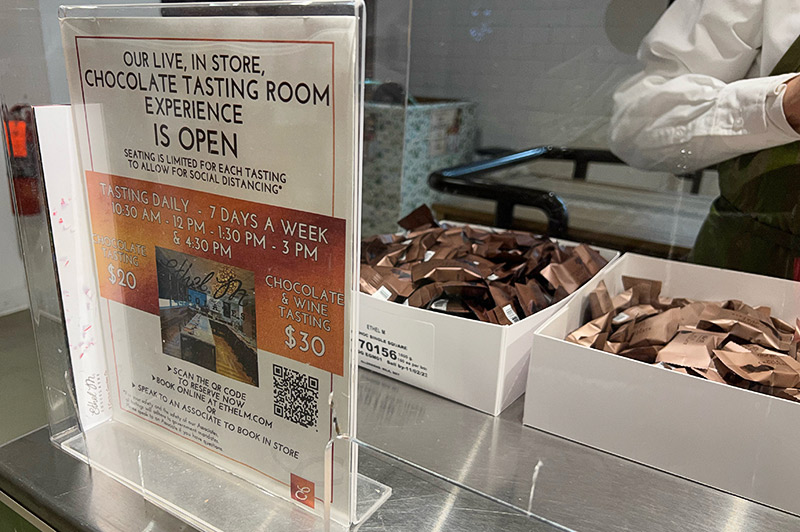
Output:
524 254 800 514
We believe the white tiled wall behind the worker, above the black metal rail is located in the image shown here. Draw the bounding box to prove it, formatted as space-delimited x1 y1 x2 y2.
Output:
410 0 667 148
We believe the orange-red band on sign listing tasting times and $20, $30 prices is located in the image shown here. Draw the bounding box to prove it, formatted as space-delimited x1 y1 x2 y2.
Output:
86 172 346 375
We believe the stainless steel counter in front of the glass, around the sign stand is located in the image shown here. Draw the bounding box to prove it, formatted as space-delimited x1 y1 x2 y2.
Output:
0 428 560 532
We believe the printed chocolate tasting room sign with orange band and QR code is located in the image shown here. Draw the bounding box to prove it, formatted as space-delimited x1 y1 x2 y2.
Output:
62 10 359 516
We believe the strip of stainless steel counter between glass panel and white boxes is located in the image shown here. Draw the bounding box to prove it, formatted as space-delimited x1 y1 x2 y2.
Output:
358 370 800 532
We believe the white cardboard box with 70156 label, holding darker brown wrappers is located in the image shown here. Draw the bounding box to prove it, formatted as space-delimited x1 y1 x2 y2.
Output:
358 242 619 416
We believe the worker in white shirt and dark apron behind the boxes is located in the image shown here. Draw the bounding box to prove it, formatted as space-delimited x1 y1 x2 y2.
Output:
609 0 800 279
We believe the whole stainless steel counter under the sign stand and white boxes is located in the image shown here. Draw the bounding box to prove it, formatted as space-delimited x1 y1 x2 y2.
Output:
0 371 800 532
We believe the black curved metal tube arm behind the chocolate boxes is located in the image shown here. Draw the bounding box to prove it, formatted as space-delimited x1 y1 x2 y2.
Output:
428 146 624 236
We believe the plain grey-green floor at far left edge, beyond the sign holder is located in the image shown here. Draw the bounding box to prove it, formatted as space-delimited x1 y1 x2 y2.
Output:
0 310 47 444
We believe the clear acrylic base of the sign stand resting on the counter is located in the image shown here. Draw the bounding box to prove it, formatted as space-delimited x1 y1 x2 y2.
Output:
61 421 392 532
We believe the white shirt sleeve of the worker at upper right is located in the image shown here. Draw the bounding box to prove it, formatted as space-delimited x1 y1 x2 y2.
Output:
609 0 800 173
